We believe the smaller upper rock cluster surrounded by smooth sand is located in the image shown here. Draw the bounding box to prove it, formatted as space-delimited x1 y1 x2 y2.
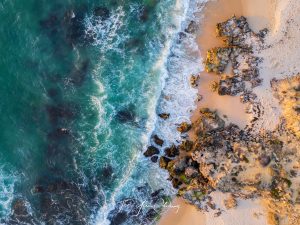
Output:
205 16 266 96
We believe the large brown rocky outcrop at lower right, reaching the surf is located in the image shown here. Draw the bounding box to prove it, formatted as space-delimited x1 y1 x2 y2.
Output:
160 108 300 214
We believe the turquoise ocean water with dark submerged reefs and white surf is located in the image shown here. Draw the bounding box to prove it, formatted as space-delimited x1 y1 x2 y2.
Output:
0 0 204 225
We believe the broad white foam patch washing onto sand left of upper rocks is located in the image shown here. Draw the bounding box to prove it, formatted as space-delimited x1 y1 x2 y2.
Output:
154 0 206 148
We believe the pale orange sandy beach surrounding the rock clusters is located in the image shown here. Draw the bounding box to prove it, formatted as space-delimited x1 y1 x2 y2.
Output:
159 0 300 225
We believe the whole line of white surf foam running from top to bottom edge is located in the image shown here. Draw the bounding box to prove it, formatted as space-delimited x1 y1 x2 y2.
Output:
92 0 206 225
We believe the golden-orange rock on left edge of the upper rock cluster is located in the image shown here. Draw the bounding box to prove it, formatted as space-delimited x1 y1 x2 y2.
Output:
204 47 232 74
